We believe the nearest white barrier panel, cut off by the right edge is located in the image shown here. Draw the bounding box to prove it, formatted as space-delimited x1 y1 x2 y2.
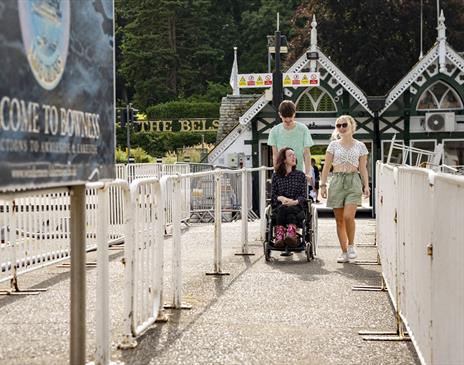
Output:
431 174 464 365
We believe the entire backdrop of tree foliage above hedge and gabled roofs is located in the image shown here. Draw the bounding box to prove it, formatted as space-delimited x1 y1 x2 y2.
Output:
115 0 464 106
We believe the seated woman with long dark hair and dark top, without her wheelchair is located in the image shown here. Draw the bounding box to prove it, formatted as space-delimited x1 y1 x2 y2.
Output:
271 147 307 248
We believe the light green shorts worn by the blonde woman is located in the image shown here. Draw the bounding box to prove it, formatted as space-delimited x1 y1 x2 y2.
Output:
327 172 362 208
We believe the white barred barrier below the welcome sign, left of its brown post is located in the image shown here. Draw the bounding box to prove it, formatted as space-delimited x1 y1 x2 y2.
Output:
0 188 70 291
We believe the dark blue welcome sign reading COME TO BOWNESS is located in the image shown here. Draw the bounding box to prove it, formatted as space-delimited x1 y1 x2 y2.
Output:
0 0 115 190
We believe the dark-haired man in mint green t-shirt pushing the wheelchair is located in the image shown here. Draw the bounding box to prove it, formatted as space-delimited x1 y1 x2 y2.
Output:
267 100 314 182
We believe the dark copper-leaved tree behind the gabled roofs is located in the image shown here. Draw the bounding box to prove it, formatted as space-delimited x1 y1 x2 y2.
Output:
288 0 464 95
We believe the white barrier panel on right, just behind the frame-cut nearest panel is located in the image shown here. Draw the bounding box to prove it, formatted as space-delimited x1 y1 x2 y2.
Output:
398 167 434 364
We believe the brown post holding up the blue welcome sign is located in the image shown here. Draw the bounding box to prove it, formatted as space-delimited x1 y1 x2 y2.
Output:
70 185 86 365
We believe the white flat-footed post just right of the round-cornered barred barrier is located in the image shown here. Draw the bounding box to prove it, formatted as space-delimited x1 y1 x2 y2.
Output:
164 175 192 309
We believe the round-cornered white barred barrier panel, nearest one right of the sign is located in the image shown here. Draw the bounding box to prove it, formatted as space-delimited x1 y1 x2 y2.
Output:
123 178 164 347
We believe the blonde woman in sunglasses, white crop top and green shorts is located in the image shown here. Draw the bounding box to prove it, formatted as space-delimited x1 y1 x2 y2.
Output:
320 115 370 263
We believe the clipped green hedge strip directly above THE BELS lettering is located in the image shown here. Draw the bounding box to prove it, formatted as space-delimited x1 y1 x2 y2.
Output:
147 101 220 120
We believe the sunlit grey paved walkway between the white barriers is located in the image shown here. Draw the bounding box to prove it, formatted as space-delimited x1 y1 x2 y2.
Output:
0 219 419 365
